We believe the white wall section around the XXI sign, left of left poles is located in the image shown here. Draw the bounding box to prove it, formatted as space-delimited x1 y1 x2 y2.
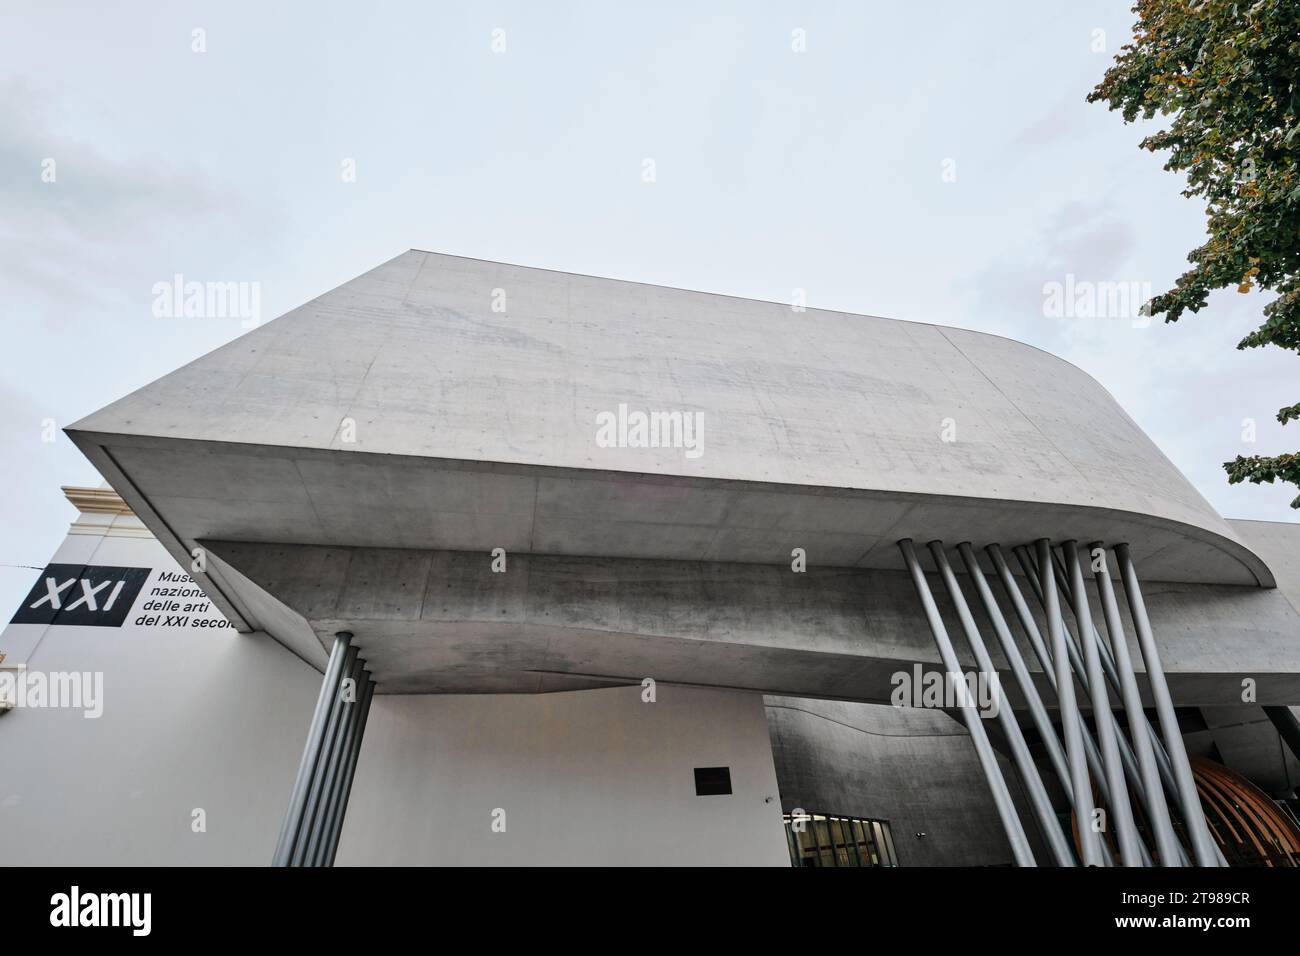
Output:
0 516 320 865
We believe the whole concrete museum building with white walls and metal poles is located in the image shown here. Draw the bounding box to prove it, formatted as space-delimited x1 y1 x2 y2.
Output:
0 251 1300 865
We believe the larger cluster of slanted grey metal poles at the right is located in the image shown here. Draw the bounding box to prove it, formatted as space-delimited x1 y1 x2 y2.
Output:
898 538 1227 866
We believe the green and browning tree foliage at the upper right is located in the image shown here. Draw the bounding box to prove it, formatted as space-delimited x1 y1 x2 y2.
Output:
1088 0 1300 509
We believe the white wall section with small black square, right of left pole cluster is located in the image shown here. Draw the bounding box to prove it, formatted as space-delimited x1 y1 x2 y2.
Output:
337 685 789 866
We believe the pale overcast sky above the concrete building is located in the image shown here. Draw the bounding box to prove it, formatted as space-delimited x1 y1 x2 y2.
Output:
0 0 1300 614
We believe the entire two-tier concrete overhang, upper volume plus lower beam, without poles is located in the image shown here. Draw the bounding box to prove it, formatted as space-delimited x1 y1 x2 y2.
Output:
68 251 1296 700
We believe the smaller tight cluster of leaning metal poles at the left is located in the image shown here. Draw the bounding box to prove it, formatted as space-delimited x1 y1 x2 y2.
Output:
274 631 374 866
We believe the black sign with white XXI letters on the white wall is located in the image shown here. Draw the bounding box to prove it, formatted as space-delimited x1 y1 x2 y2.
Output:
12 564 150 627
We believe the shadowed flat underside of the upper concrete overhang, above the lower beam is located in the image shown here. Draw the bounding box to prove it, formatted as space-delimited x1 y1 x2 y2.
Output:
70 429 1273 587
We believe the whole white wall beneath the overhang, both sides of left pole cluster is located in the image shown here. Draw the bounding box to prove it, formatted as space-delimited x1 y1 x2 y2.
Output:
0 502 789 866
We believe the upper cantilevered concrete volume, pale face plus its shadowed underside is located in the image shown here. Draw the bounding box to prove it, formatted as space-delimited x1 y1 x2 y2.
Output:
69 250 1273 585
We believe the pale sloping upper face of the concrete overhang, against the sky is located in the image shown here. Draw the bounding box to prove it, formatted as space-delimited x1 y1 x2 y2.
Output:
61 250 1248 572
